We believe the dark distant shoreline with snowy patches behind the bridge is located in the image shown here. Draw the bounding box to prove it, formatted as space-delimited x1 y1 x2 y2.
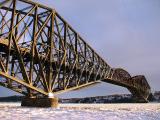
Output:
0 91 160 103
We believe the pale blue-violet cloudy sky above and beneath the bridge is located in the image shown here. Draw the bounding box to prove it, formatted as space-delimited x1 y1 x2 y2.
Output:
0 0 160 97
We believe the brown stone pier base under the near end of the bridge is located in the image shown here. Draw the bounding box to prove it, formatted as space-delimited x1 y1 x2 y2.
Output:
21 98 58 108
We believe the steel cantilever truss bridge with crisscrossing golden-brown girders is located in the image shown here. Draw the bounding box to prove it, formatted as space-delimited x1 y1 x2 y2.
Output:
0 0 150 102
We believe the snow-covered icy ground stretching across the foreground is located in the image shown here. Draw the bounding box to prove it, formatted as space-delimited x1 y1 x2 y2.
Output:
0 103 160 120
